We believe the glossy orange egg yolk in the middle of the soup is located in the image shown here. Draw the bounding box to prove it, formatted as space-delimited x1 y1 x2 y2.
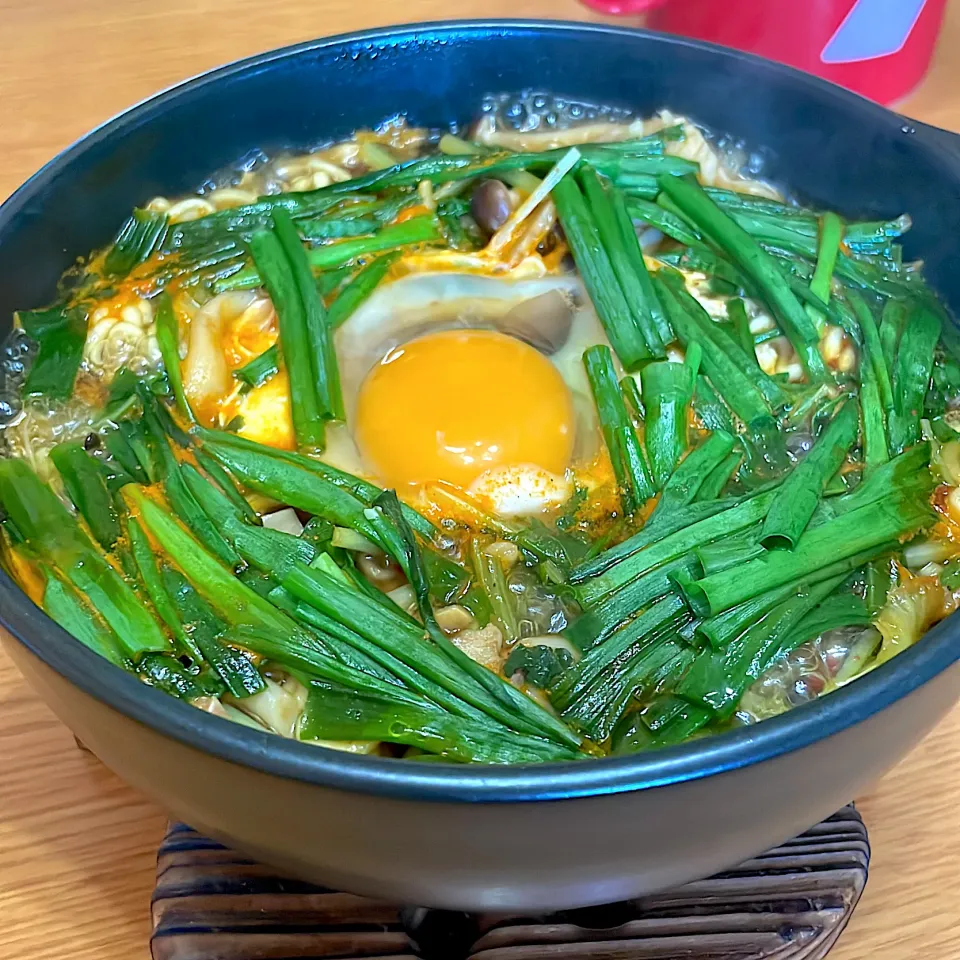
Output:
354 330 575 496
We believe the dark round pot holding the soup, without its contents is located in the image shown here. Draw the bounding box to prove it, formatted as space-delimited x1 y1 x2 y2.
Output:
0 22 960 910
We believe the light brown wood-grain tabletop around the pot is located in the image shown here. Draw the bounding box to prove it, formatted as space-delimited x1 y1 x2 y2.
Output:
0 0 960 960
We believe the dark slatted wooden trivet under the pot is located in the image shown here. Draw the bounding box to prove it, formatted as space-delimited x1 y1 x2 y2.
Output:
150 806 870 960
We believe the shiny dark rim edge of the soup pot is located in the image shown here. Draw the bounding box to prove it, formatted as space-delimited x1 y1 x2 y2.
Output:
0 19 960 803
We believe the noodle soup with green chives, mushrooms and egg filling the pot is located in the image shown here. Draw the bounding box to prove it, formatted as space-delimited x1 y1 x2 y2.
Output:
0 95 960 763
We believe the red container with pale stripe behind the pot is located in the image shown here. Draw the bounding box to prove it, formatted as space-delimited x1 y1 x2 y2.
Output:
584 0 947 104
